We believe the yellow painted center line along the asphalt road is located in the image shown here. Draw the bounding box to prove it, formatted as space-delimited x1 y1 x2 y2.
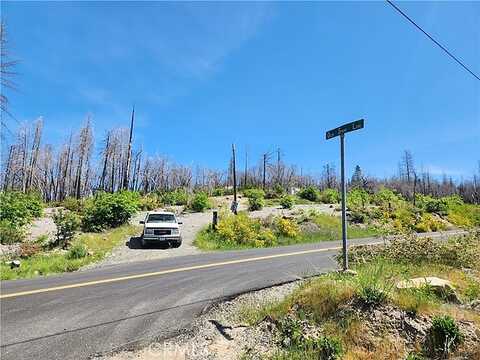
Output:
0 242 381 299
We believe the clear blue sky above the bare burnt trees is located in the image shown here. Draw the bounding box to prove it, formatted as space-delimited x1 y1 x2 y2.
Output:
2 2 480 178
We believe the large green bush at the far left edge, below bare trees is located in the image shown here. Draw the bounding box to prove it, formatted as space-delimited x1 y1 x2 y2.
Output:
0 191 42 226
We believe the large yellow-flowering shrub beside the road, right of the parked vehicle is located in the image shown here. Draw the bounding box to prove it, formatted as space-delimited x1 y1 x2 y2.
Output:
215 213 276 247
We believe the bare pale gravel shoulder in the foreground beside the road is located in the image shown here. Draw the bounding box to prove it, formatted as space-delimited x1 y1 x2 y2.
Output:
98 281 301 360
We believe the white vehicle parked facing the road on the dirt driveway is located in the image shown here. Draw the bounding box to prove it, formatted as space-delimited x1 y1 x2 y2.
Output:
140 211 182 248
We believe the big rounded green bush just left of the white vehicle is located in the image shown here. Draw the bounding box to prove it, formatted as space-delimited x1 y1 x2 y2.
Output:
82 191 140 232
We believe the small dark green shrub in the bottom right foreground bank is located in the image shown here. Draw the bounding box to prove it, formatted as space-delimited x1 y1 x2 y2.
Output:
427 315 464 355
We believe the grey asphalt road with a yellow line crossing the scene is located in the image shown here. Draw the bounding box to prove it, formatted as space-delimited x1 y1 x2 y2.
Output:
0 231 464 360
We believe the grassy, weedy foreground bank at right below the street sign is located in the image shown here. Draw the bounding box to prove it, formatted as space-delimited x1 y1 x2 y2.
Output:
237 235 480 359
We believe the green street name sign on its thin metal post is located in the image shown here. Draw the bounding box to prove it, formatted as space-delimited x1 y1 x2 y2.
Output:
325 119 364 271
